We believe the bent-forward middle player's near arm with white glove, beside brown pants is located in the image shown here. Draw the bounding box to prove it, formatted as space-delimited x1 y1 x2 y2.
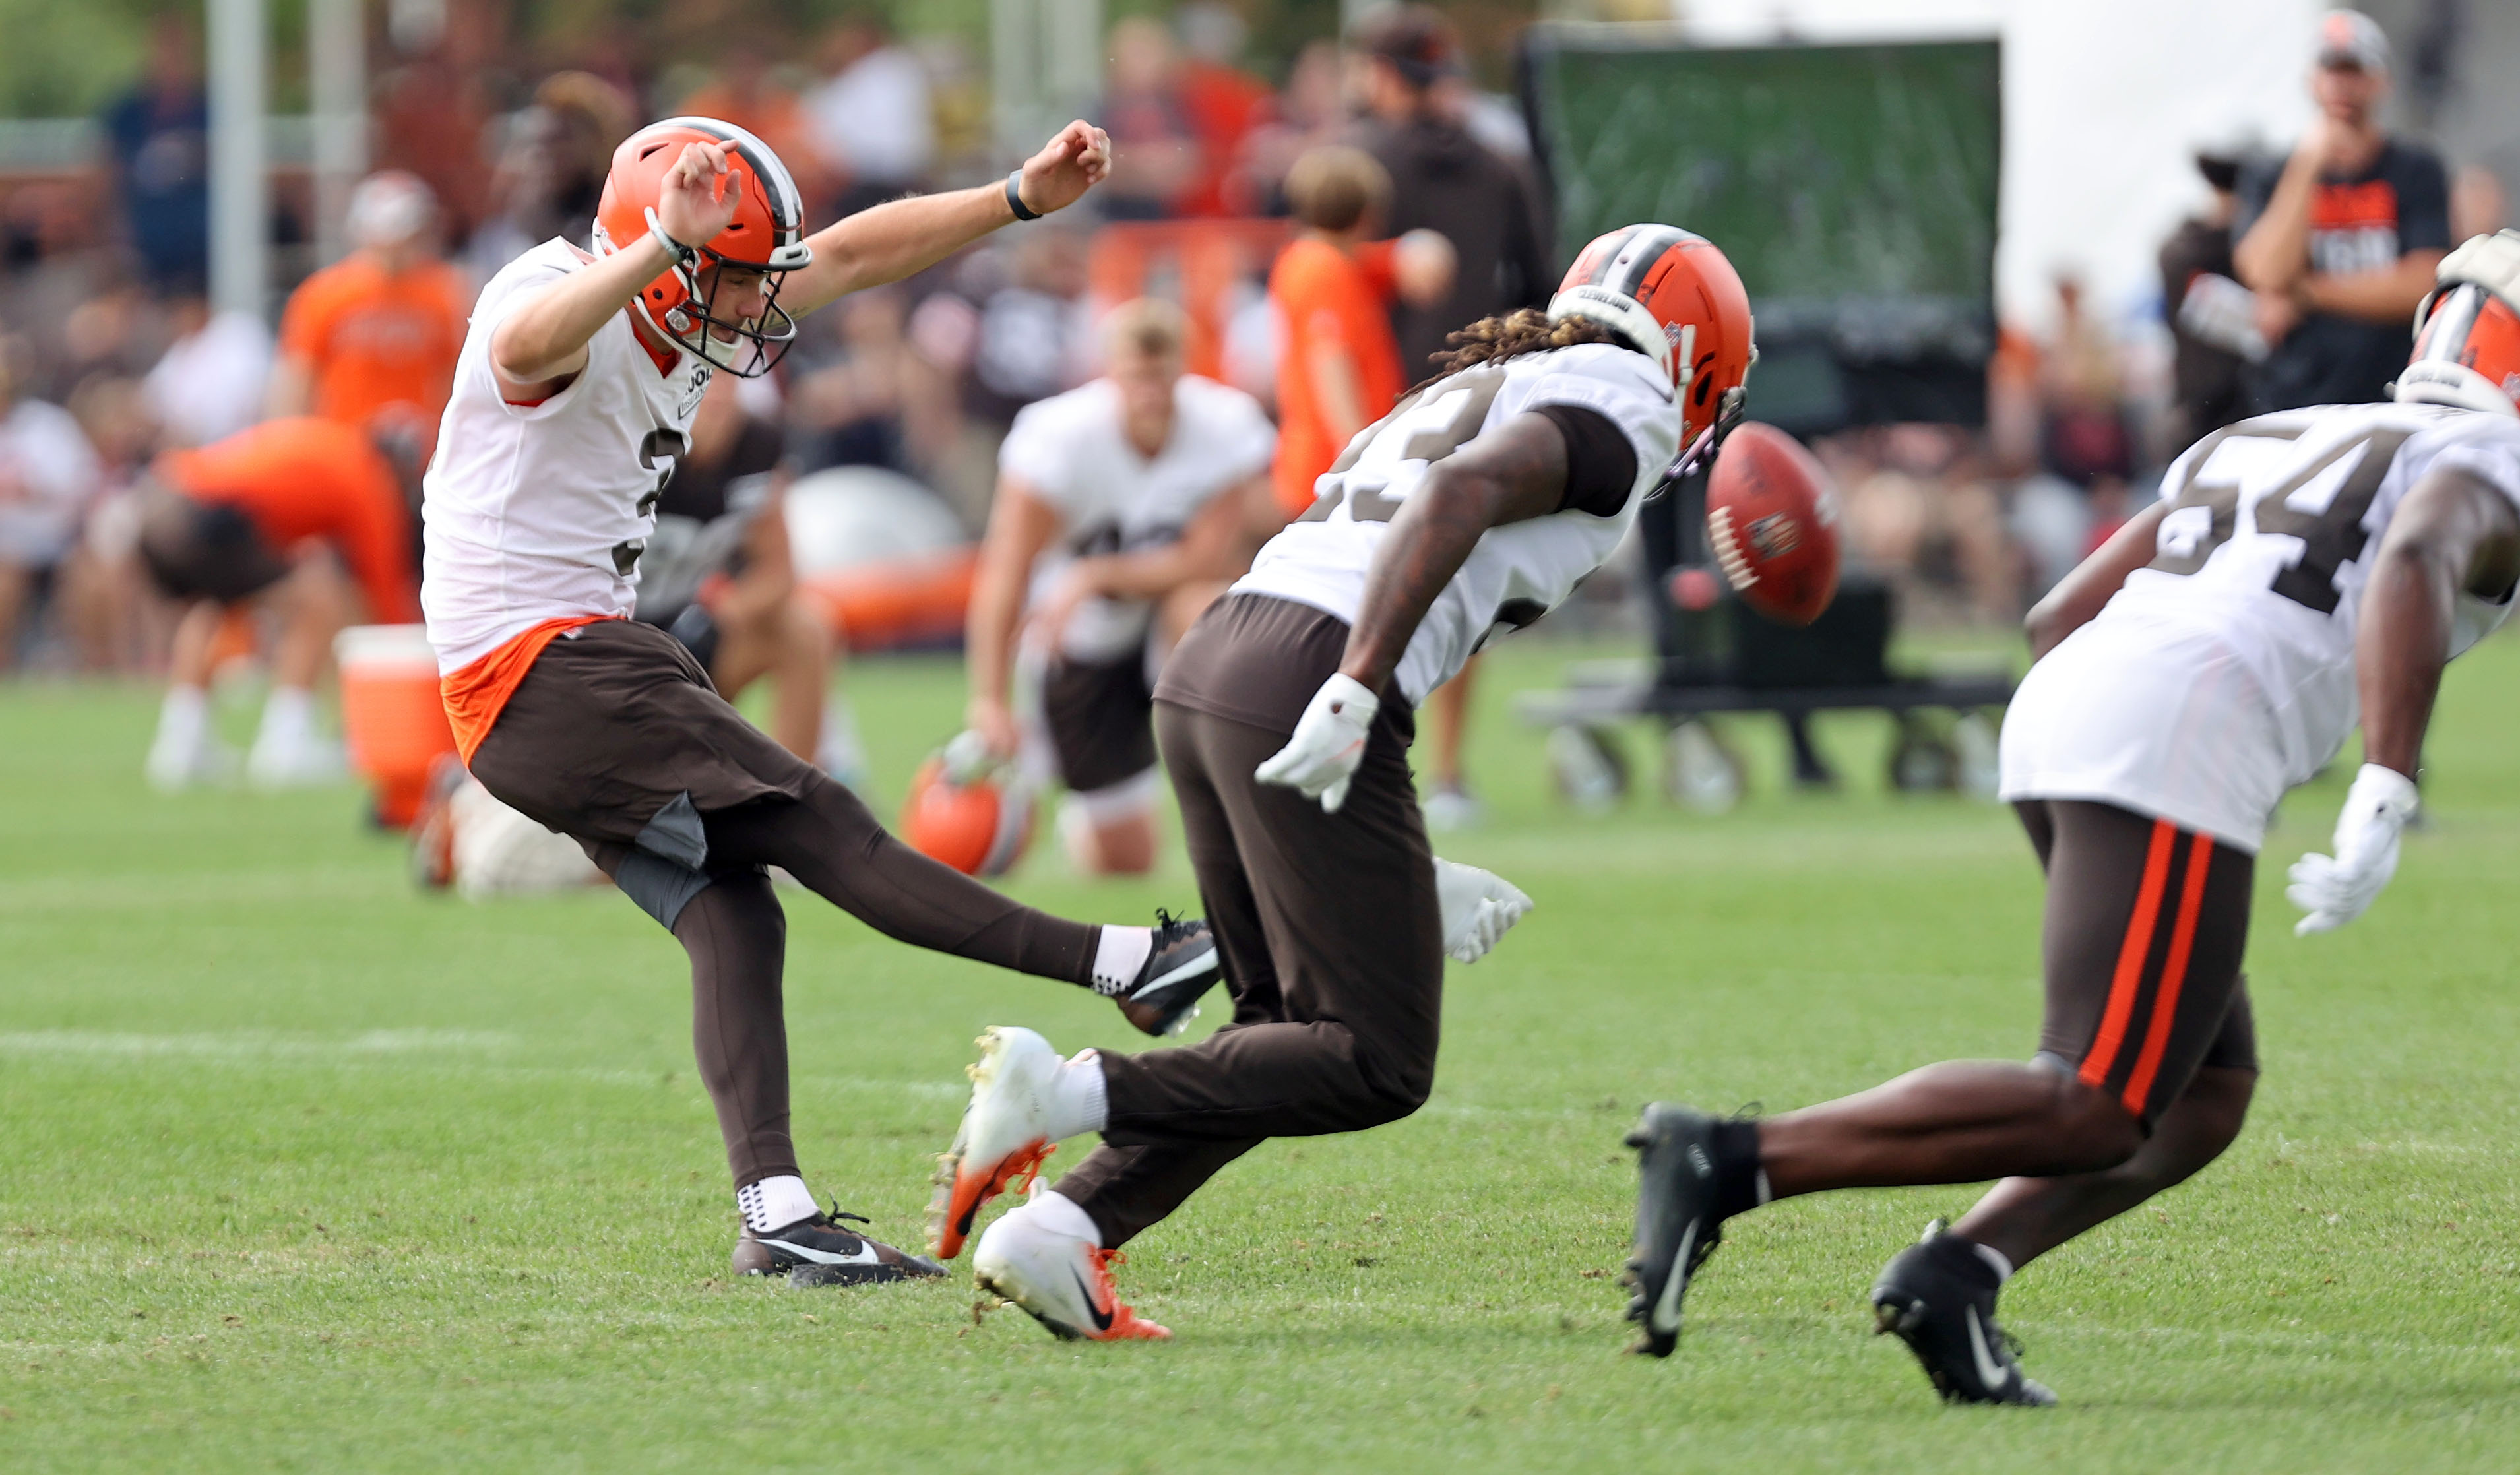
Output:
1253 414 1567 815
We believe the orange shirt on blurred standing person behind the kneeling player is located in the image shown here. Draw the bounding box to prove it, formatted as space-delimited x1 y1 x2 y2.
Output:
1267 237 1406 517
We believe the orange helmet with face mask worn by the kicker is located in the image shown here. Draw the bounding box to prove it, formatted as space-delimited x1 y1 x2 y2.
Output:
595 119 814 378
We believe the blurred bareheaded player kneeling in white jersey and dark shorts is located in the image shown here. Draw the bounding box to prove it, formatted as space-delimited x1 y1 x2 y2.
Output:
968 298 1278 875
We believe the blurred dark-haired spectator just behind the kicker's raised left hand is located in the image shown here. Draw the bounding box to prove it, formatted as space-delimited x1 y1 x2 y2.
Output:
464 71 635 282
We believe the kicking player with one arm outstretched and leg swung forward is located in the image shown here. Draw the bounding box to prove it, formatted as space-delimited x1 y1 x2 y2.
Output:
421 119 1217 1281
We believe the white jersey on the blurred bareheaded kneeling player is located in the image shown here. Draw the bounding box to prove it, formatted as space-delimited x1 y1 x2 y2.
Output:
998 373 1278 660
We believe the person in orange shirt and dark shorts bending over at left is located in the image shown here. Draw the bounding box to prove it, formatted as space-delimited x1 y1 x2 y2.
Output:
139 416 421 789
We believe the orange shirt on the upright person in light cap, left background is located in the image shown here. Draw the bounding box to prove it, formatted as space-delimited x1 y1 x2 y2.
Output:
280 252 471 449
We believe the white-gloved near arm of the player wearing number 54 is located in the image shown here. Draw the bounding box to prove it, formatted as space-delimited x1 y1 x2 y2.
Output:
2283 466 2520 933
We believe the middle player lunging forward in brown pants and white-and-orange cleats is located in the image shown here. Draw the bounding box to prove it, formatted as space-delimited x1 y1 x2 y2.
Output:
932 224 1754 1339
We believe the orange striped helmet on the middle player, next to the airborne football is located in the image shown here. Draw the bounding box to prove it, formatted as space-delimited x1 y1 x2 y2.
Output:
1550 224 1759 447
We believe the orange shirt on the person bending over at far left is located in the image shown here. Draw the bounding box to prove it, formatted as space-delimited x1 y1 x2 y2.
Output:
156 416 421 625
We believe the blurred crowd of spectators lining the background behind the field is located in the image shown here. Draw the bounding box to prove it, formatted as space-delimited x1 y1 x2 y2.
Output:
0 0 2502 671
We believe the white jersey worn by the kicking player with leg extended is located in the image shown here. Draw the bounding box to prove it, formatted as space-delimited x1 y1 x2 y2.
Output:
421 239 710 674
